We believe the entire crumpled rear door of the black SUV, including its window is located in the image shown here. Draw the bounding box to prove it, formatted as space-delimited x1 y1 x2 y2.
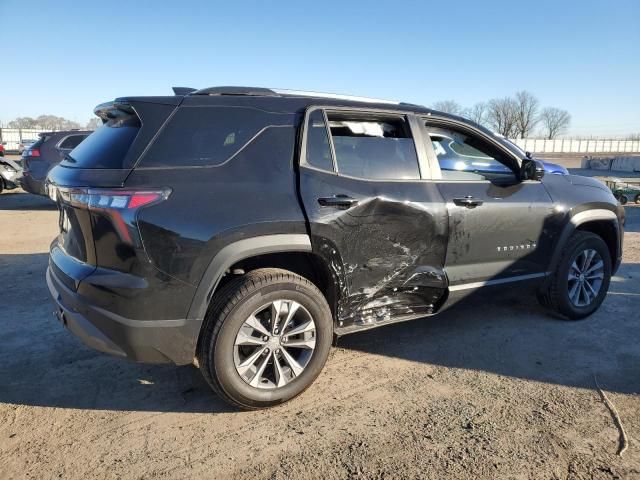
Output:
300 107 448 329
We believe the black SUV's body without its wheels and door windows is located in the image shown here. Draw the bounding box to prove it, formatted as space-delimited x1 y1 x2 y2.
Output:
47 88 623 364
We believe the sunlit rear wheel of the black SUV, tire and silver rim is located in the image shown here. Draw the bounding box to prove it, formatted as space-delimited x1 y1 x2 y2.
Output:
197 268 333 410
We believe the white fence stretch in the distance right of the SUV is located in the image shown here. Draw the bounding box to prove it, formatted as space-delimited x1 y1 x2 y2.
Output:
511 138 640 153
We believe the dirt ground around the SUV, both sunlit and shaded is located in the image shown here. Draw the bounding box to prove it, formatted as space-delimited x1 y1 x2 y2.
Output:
0 192 640 479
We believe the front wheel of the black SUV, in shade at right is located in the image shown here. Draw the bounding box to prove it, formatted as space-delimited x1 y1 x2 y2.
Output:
538 231 611 320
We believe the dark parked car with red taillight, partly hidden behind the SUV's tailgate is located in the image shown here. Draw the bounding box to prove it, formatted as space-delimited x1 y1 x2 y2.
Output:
20 130 92 196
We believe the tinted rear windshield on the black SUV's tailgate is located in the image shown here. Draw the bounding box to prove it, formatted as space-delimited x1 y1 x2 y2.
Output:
62 116 140 168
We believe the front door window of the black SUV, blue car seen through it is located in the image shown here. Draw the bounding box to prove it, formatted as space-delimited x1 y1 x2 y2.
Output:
426 124 516 180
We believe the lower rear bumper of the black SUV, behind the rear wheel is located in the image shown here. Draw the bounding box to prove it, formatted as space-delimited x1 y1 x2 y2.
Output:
46 268 202 365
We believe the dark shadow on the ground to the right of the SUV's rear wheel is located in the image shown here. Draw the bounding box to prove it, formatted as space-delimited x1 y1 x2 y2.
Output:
339 264 640 393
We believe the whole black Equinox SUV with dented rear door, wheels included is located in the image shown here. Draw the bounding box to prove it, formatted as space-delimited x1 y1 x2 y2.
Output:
47 87 624 408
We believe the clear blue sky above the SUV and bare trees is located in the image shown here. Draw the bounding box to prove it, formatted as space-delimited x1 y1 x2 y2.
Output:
0 0 640 135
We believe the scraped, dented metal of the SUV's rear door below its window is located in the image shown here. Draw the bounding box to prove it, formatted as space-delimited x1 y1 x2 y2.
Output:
300 167 448 328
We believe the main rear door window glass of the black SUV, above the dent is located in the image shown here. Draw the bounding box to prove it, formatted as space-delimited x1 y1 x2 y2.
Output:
327 112 420 180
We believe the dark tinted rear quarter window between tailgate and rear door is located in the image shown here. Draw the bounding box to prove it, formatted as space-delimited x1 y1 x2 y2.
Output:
141 107 292 167
